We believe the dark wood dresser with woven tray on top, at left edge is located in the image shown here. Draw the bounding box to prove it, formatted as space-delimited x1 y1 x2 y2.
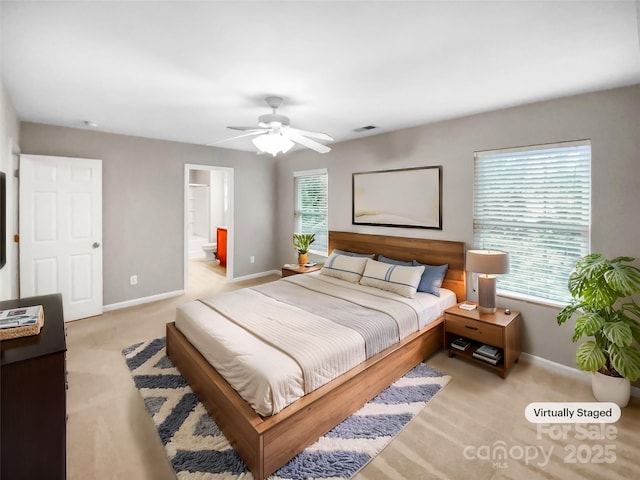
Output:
0 294 67 480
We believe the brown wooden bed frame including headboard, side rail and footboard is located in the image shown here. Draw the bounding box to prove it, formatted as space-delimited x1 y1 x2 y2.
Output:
167 232 466 480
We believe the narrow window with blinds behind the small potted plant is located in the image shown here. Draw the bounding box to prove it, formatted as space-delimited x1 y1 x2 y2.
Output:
293 169 329 255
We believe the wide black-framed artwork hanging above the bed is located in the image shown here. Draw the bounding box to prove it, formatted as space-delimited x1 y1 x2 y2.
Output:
351 165 442 230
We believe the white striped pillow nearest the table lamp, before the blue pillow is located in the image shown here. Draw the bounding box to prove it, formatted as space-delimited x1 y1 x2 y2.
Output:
360 259 424 298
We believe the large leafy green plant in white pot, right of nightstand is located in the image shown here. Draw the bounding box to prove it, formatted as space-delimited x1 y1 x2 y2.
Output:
557 253 640 407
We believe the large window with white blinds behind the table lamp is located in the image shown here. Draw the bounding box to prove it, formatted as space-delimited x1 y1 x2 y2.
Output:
473 141 591 303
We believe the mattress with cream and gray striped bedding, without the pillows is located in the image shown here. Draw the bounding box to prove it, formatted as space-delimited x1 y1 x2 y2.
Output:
176 272 456 416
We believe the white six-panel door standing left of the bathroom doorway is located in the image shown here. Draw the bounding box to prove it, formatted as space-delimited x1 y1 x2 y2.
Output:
19 155 103 323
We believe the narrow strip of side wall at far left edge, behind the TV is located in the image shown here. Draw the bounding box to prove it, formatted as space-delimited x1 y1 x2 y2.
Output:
0 80 20 300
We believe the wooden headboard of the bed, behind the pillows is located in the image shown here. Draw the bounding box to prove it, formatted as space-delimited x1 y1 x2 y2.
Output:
329 231 467 302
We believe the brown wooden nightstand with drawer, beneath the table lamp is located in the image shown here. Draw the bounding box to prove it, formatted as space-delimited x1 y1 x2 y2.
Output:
444 302 521 378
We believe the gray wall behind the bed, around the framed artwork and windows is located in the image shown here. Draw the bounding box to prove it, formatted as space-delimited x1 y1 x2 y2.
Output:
277 86 640 367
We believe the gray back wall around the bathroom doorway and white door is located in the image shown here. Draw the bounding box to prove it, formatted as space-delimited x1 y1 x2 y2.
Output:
20 122 276 305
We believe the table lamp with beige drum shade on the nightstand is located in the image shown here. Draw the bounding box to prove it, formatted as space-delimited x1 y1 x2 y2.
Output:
467 250 509 313
